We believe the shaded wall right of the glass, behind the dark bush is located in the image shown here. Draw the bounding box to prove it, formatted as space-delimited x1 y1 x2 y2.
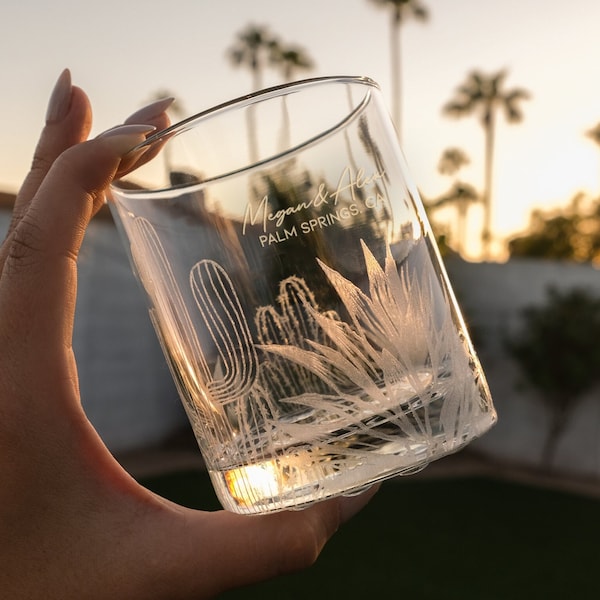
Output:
446 259 600 475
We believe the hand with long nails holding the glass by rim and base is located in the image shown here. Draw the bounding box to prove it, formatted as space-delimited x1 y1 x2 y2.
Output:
0 71 373 600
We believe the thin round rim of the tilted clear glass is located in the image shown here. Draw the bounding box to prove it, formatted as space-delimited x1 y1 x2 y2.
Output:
111 75 381 194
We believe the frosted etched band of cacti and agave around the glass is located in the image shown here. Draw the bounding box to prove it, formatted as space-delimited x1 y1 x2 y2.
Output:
132 213 491 468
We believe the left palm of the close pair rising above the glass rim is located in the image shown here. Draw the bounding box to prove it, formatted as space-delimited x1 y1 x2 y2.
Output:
227 25 278 91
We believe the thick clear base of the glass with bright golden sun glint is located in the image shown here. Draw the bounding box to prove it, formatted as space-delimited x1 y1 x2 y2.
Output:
209 411 496 514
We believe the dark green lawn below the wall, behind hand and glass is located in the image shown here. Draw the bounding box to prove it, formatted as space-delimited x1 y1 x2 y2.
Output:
142 472 600 600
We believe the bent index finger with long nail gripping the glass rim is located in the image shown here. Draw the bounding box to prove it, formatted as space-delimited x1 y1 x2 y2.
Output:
0 125 153 362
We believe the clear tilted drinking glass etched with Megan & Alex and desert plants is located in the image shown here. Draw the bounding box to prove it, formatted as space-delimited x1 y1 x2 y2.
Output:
110 77 496 514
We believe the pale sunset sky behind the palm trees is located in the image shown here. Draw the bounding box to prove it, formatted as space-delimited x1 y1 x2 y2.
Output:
0 0 600 259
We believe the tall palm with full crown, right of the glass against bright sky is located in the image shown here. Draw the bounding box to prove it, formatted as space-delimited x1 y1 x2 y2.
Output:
443 70 529 258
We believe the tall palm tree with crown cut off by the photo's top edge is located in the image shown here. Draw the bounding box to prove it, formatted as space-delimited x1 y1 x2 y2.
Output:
370 0 429 139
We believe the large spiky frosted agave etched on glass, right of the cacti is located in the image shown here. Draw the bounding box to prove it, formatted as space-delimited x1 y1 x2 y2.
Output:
259 243 479 450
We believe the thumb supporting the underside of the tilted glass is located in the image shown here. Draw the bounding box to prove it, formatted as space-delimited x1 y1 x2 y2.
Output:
155 486 378 599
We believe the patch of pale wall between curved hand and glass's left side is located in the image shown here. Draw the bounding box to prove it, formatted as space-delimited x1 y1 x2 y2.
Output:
73 221 187 452
